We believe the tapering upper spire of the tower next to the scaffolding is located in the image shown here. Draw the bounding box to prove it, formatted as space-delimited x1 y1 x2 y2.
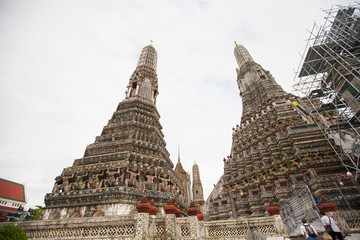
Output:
234 42 287 118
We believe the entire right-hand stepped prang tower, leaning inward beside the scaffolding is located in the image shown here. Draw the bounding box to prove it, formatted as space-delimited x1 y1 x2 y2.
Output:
204 43 360 220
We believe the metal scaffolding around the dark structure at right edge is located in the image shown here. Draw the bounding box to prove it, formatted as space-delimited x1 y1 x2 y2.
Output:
293 3 360 179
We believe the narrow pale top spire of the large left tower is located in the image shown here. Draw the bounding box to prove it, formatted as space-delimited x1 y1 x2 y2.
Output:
126 45 158 104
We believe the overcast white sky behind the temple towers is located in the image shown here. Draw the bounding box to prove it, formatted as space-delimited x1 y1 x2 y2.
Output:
0 0 352 207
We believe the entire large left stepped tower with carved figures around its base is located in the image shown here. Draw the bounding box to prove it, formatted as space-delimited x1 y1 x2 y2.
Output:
43 45 190 219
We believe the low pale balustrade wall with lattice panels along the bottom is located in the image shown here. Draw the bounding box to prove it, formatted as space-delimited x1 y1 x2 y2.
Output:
0 211 360 240
